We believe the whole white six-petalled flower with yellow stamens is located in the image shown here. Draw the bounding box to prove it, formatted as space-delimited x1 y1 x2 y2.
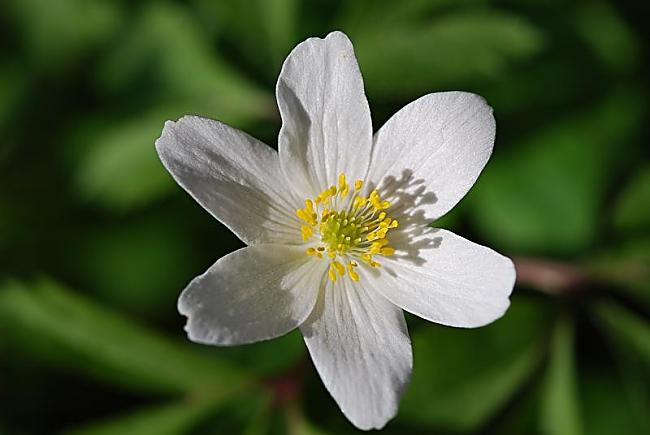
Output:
156 32 515 429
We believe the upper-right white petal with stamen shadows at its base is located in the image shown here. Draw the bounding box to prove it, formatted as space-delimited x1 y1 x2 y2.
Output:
368 92 496 223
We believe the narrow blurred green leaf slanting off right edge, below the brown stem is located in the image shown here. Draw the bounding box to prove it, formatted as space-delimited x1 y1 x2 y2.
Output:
595 302 650 367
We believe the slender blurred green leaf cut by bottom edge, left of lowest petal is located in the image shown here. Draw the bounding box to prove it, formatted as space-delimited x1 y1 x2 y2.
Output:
65 402 213 435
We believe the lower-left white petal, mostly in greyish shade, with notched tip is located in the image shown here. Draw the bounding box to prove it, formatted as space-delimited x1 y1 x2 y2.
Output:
178 244 325 345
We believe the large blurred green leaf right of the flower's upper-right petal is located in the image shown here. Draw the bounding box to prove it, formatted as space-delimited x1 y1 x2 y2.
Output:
467 92 642 254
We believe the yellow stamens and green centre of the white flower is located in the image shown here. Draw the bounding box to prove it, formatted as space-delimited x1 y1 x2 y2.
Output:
296 174 398 282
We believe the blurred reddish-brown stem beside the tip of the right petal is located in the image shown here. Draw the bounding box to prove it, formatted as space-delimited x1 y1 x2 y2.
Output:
513 257 588 294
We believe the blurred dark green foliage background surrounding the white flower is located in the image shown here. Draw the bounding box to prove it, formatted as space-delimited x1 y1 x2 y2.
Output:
0 0 650 435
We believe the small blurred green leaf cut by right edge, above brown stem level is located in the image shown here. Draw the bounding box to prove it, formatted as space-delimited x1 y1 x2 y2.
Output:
614 165 650 233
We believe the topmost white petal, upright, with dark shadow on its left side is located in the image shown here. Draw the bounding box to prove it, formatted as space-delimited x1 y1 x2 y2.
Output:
276 32 372 196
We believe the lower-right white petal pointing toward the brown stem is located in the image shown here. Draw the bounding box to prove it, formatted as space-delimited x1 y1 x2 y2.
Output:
360 228 515 328
